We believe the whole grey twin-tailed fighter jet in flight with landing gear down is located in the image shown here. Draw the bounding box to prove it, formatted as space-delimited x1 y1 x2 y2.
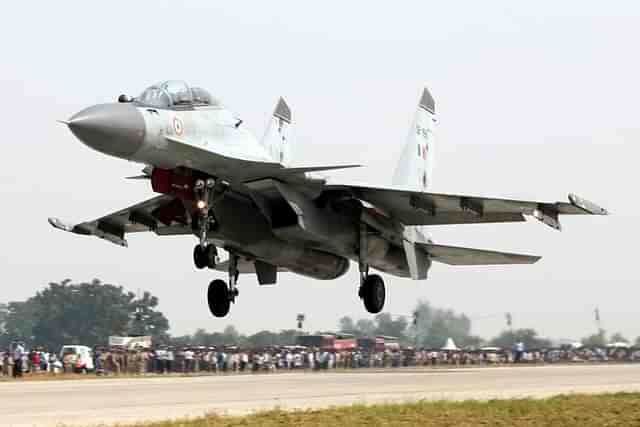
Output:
49 81 607 317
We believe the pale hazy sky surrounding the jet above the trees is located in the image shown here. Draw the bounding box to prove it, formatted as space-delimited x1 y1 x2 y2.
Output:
0 0 640 339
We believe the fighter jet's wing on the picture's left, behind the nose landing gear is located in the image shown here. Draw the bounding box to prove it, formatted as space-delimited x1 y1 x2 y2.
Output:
49 195 192 246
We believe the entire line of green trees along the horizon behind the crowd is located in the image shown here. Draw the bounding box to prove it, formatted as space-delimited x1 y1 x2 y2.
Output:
0 279 640 349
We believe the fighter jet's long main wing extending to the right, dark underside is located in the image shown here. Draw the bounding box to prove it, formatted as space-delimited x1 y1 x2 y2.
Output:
324 185 608 230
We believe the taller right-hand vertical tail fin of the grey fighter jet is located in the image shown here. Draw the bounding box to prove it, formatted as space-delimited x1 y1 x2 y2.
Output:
393 88 436 191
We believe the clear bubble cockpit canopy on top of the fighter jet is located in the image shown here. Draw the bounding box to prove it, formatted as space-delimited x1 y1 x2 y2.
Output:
135 80 221 109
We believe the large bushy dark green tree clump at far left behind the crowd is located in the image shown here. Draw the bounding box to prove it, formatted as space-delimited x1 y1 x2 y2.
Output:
0 279 169 349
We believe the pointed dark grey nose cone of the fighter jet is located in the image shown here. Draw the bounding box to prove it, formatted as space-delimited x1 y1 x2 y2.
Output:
67 103 145 158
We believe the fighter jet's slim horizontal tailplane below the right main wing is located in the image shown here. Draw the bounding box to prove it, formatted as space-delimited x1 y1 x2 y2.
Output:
416 243 541 265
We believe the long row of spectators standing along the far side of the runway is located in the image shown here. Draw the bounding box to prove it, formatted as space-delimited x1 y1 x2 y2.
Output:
0 344 640 377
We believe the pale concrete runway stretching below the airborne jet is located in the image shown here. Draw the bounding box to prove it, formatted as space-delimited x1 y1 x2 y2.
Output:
0 364 640 426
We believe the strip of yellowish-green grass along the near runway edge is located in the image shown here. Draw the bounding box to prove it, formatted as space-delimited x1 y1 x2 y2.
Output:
100 393 640 427
